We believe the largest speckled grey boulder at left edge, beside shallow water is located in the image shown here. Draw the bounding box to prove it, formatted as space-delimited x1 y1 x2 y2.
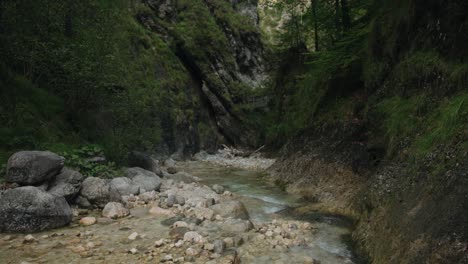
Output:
0 186 73 233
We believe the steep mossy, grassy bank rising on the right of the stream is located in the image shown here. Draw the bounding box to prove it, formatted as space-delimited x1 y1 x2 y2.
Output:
267 0 468 263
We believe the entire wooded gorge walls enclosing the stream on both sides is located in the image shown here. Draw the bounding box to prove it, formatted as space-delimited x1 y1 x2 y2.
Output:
0 0 468 263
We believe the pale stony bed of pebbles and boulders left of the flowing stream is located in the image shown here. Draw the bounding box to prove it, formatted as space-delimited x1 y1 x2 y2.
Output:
0 152 355 263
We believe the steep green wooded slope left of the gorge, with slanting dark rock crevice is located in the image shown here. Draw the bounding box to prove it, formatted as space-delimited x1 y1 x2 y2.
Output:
0 0 265 165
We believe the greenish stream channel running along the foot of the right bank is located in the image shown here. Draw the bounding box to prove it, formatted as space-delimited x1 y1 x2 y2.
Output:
183 162 361 264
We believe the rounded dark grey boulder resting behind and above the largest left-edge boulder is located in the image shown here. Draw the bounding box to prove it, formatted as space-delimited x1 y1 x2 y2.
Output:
5 151 65 185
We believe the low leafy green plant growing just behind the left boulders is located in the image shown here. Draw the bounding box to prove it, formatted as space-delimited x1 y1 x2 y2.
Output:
60 145 121 178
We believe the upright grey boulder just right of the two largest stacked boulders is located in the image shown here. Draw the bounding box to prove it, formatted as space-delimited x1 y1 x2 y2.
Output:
47 168 84 202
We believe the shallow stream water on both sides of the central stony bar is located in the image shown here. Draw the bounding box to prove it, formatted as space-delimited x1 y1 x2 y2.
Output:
0 162 356 264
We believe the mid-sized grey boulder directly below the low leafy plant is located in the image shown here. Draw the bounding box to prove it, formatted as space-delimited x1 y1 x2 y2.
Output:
80 177 122 208
